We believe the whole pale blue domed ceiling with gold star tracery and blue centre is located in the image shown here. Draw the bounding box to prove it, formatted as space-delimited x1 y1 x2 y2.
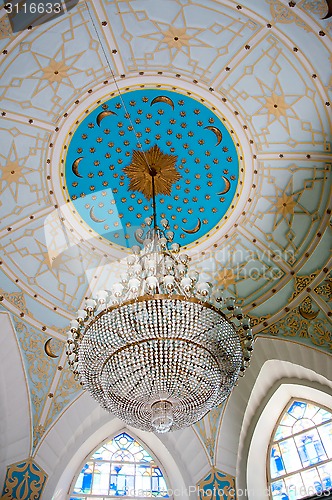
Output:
0 0 332 462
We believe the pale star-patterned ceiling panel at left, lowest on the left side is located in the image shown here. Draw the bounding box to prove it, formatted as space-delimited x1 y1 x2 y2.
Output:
2 218 99 313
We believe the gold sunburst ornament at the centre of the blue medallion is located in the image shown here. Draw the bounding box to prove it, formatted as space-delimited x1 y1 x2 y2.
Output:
123 145 181 200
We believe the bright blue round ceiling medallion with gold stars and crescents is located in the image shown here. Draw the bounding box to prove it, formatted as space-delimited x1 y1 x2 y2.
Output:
65 89 239 247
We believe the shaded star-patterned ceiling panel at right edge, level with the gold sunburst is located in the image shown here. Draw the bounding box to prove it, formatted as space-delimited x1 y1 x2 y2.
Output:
248 160 330 258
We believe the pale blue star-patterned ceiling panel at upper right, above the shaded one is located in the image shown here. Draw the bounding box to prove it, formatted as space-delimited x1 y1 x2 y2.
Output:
218 34 330 153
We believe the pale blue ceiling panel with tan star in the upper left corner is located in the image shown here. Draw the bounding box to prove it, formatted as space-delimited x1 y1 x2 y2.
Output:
0 6 109 124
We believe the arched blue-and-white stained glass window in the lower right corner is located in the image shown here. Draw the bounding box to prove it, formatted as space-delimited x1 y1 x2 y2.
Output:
268 400 332 500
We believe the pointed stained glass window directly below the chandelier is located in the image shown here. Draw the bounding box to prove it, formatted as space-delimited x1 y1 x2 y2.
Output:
70 432 169 500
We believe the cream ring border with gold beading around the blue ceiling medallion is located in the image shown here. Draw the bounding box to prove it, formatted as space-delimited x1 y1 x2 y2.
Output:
47 75 257 259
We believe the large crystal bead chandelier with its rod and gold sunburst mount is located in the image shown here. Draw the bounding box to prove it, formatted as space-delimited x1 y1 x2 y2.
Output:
67 146 253 433
